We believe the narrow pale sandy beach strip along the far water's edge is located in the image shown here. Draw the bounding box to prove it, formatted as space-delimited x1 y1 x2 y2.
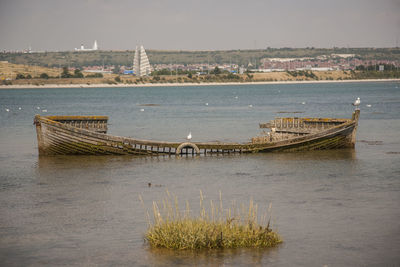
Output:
0 79 400 90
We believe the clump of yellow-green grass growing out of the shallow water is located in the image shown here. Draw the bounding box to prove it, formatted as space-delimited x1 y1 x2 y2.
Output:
140 191 282 250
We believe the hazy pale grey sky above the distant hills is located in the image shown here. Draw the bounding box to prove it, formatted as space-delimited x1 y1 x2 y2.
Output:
0 0 400 51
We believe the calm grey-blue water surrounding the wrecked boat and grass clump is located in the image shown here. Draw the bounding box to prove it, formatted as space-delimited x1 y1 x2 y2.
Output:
0 82 400 266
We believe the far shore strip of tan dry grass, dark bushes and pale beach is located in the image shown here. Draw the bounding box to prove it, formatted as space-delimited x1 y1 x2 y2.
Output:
0 62 400 89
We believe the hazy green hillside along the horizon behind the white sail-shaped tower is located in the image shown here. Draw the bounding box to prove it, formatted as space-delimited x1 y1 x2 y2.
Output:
0 48 400 67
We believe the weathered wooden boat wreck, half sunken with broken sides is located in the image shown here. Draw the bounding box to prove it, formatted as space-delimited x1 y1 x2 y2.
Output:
34 109 360 155
